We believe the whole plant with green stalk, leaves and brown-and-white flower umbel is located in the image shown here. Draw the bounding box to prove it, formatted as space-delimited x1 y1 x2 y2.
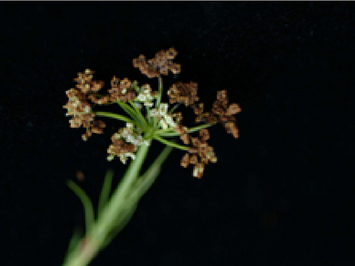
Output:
63 48 241 266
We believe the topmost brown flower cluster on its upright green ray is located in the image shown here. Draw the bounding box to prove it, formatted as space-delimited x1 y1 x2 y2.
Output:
133 48 181 78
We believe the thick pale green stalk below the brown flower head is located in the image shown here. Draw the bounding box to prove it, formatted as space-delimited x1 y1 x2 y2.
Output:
63 143 172 266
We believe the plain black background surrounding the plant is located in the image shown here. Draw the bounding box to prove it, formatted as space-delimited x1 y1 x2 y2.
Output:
0 2 355 266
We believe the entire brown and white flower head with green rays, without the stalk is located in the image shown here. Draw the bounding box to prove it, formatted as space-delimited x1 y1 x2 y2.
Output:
64 48 241 178
